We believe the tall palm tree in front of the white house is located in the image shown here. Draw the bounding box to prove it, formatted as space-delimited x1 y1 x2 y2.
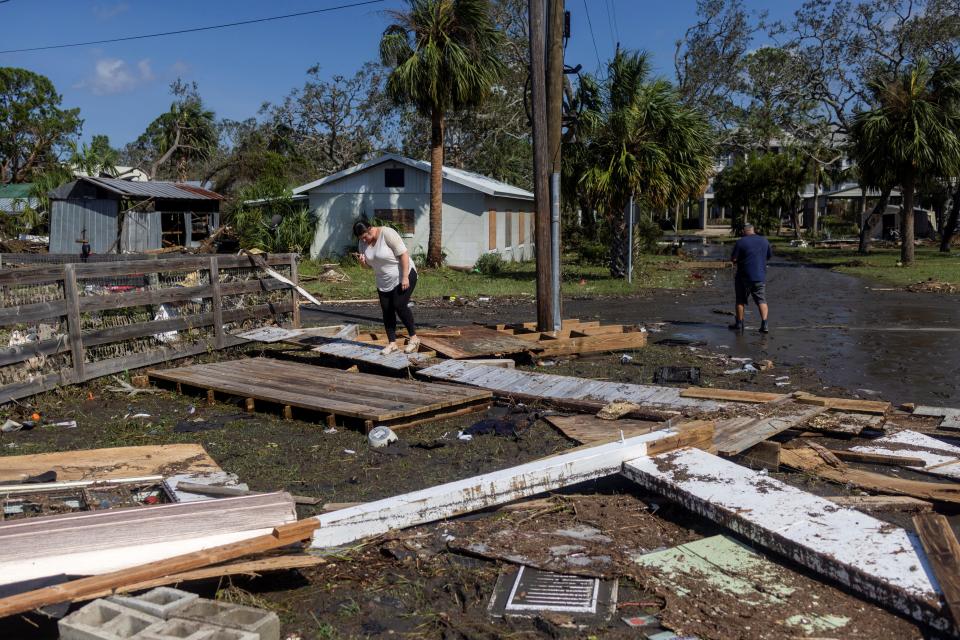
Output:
380 0 503 266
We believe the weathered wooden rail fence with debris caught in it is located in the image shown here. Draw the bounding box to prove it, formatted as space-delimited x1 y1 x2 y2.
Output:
0 254 300 402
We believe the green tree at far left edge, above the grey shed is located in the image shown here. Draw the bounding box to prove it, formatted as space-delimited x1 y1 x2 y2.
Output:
0 67 83 183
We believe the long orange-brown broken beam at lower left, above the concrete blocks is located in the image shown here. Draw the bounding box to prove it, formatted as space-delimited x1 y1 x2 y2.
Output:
0 518 320 618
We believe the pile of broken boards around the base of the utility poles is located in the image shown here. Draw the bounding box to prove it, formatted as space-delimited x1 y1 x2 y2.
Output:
488 320 647 358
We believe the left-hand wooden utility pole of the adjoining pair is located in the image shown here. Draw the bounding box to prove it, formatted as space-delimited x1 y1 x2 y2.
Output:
527 0 553 331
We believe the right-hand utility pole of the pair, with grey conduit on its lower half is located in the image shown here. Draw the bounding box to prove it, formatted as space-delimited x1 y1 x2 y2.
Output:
547 0 564 331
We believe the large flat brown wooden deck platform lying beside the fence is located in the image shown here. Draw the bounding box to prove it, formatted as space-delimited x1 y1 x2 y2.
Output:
149 358 492 431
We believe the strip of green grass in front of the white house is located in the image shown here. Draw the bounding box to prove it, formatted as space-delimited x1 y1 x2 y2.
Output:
300 256 700 300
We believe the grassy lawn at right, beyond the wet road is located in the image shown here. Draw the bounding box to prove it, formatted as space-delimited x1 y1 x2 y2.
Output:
774 243 960 287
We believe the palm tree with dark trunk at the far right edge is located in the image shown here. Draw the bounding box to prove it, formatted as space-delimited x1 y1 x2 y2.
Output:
852 60 960 265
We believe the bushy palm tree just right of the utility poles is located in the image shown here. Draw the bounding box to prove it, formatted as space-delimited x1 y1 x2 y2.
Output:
580 50 713 277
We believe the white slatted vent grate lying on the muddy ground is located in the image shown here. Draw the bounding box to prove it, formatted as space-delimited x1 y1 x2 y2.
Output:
505 566 600 613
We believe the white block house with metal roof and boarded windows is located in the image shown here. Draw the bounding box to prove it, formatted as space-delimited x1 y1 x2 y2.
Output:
293 153 533 267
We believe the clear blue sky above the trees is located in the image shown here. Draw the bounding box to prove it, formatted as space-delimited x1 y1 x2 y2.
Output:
0 0 799 146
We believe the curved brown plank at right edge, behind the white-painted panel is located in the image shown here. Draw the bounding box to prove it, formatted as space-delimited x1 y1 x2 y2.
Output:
780 448 960 504
